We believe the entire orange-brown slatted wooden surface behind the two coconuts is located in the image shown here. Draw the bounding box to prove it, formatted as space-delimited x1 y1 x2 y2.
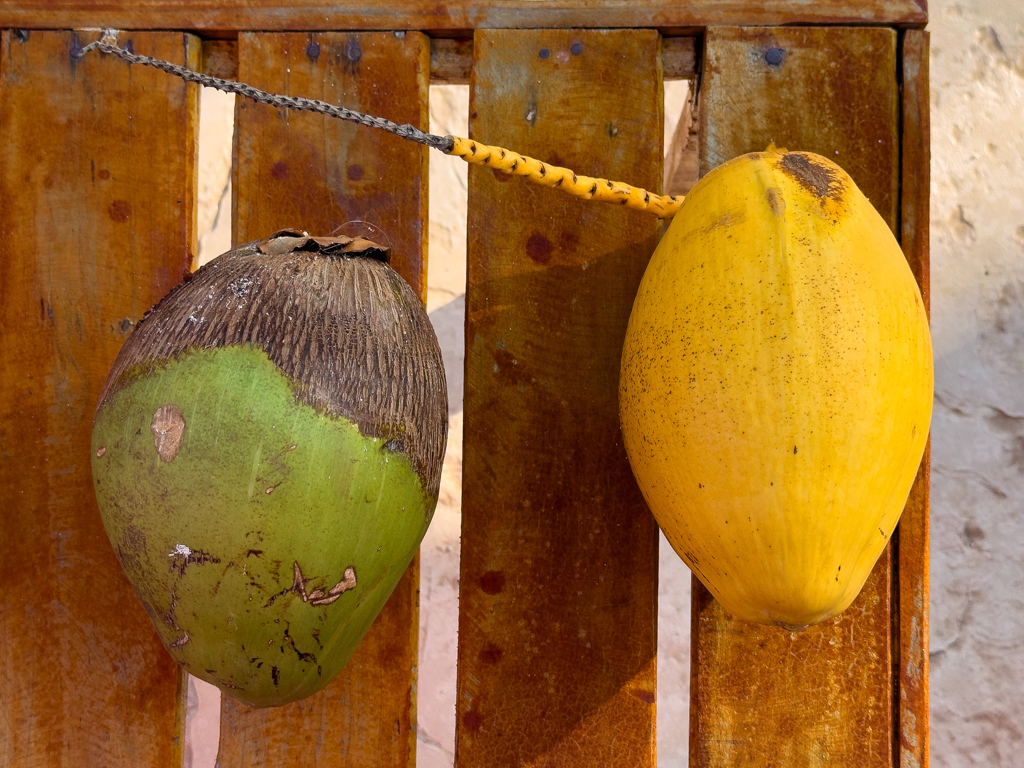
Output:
0 0 929 768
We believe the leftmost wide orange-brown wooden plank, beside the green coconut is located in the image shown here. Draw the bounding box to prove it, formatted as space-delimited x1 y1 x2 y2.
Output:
0 31 200 768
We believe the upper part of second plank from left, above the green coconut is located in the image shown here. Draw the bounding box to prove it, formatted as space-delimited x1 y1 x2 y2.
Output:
232 32 430 297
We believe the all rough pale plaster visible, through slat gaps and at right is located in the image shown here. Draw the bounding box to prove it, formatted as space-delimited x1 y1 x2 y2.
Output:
186 10 1024 768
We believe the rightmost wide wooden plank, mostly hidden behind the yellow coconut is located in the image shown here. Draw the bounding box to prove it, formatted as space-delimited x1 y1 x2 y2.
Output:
690 28 899 768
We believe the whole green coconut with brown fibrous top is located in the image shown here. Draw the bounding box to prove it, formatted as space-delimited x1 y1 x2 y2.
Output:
92 230 447 707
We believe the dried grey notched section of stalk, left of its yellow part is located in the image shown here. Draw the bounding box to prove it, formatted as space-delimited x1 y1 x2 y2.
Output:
73 30 455 155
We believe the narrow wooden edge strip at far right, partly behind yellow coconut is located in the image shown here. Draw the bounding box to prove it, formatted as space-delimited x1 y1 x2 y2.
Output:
896 30 931 768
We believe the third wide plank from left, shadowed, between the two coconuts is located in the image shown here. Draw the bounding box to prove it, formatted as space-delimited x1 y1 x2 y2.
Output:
457 30 663 768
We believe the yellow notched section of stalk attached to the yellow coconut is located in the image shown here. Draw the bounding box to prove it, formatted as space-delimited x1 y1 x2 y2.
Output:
449 136 683 219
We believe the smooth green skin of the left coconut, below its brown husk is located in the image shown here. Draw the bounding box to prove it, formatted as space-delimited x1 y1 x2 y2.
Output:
92 345 437 707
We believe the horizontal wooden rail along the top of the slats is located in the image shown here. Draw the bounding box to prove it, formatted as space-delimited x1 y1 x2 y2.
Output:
0 0 928 33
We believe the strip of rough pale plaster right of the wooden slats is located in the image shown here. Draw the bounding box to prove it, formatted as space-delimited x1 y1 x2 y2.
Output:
930 0 1024 768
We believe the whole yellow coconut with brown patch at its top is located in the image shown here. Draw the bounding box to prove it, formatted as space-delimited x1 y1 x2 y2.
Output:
620 147 933 629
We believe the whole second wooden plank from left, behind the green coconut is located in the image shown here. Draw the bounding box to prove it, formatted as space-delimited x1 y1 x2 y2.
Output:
219 32 430 768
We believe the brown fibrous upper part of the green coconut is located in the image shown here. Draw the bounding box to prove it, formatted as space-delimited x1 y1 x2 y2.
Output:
98 229 447 498
